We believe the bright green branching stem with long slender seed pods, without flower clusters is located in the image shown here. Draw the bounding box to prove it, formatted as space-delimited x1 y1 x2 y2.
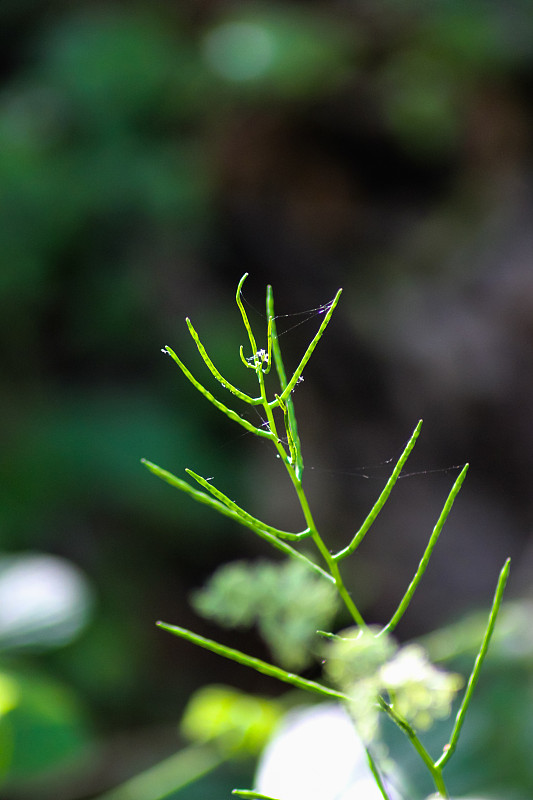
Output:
143 273 509 800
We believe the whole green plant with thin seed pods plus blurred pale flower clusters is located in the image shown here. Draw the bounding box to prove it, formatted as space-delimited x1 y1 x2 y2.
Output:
138 274 510 800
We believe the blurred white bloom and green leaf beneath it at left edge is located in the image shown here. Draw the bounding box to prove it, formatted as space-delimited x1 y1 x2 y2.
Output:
0 553 93 791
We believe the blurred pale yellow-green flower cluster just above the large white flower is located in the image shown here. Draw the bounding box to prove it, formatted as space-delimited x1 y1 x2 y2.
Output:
324 628 463 742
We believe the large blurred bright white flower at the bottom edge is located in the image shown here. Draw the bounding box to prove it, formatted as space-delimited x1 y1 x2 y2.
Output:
255 703 398 800
